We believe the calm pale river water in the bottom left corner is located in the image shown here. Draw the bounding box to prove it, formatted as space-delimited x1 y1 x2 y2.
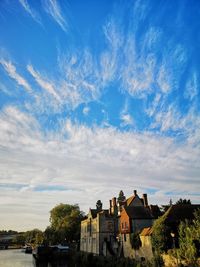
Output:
0 249 67 267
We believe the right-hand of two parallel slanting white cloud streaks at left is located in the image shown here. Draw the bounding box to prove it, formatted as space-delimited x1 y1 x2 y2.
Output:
27 65 61 101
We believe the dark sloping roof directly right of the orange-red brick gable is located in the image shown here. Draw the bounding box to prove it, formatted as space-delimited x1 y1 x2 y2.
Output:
124 206 153 219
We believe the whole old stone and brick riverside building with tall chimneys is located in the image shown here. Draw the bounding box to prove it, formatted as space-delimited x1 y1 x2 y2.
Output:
80 190 160 258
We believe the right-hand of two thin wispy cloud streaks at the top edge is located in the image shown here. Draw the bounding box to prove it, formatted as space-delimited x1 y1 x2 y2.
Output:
44 0 68 32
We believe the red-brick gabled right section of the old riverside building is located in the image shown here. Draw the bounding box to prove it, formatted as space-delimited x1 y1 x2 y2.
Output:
119 190 160 259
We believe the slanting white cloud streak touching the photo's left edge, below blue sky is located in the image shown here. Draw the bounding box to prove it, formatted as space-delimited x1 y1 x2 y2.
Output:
0 59 31 92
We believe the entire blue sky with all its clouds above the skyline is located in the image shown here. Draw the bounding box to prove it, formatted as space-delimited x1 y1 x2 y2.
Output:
0 0 200 230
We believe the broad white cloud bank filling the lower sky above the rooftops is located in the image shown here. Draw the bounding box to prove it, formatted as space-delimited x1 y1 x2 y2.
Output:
0 107 200 229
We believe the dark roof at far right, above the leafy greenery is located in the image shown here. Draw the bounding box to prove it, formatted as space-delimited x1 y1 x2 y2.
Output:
164 204 200 223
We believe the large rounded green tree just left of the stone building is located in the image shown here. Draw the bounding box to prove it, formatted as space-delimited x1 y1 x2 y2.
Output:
50 203 83 243
